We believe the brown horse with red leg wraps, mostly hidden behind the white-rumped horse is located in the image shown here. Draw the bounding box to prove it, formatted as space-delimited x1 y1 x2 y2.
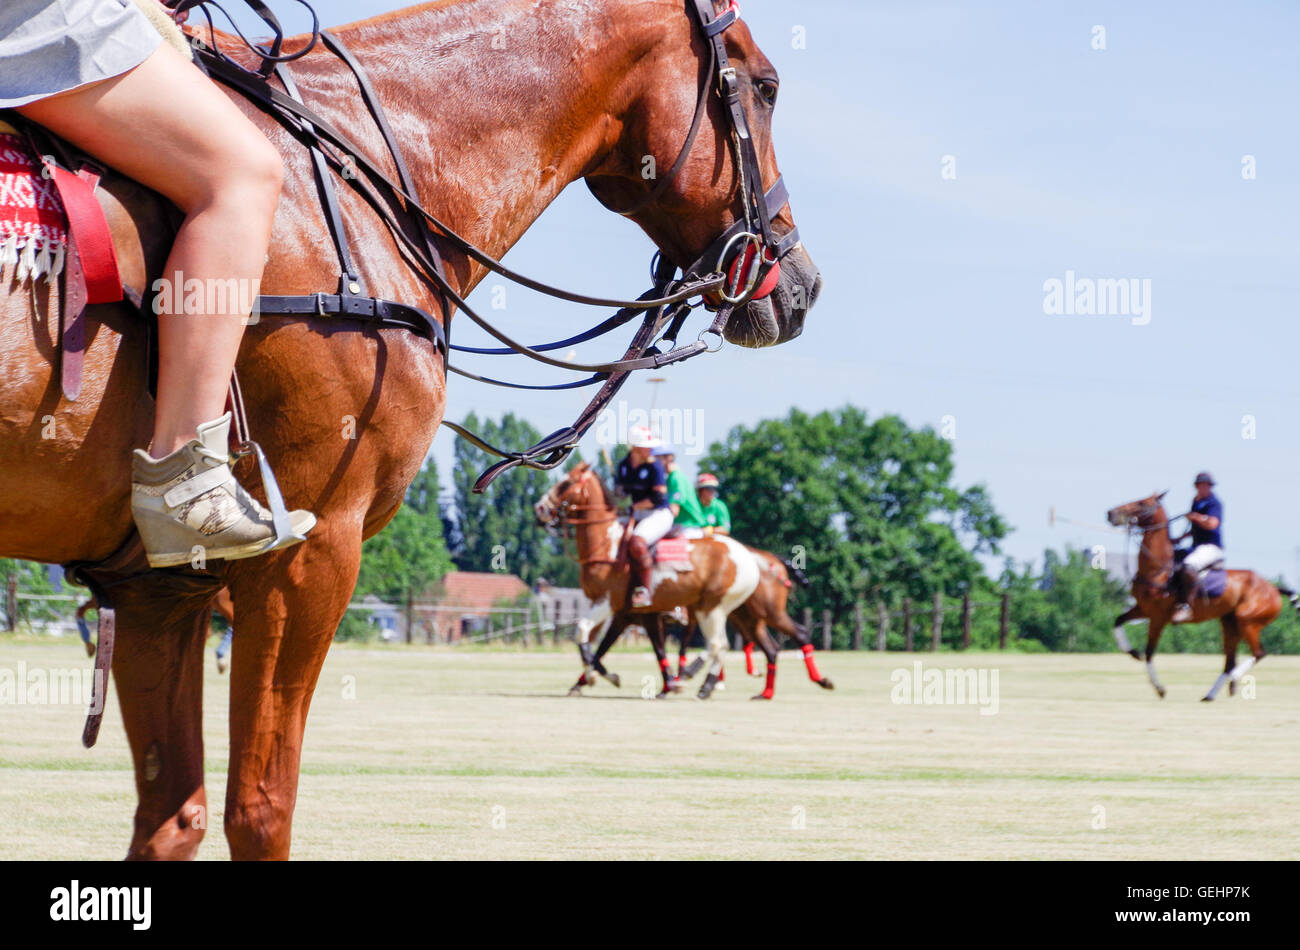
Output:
593 545 835 699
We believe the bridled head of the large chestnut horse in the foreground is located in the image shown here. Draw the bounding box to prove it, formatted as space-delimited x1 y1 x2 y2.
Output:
585 0 822 347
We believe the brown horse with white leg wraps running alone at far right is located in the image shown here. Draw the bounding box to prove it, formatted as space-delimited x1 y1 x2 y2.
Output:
1106 491 1300 702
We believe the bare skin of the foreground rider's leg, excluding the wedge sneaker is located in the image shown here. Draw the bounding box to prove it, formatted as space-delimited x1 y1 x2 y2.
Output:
20 44 283 457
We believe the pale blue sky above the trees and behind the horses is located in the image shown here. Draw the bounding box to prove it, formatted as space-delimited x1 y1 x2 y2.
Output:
271 0 1300 580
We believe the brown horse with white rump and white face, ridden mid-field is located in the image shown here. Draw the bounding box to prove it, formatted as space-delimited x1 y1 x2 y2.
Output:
534 461 759 699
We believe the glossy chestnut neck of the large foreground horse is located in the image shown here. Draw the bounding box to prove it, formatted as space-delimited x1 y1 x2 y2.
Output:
334 0 676 294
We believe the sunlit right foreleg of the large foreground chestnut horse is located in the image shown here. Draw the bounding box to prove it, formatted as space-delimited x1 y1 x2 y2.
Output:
225 535 361 860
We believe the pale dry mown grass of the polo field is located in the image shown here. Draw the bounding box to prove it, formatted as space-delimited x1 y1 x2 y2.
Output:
0 641 1300 859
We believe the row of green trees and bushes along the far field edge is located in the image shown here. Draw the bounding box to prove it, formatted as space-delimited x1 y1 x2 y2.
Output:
0 405 1300 652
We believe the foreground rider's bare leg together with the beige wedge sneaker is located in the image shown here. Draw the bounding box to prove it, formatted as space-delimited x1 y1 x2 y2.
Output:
22 44 316 568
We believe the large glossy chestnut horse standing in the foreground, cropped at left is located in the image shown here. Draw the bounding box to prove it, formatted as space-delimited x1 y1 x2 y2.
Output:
0 0 820 859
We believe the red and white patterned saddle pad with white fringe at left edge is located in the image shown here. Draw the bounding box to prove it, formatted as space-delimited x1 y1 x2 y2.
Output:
0 131 68 283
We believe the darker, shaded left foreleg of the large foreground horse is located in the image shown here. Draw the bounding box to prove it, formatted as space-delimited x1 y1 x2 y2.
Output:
113 574 215 860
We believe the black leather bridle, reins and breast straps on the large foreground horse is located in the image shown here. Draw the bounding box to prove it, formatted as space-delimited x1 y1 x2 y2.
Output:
166 0 800 493
